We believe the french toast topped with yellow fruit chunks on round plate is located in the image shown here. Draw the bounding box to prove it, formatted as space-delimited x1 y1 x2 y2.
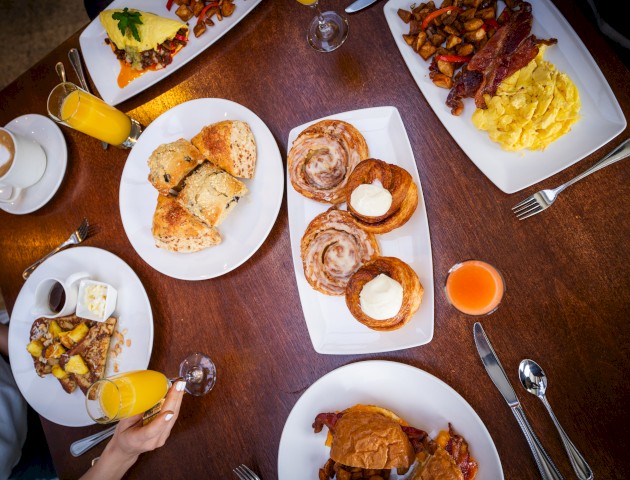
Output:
26 315 117 393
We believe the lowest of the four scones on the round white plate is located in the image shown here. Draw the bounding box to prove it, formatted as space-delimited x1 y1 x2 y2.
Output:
151 195 221 252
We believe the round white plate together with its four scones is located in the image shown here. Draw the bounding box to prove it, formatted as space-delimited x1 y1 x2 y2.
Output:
119 98 284 280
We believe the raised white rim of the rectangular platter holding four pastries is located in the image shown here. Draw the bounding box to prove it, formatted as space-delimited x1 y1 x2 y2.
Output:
284 105 435 355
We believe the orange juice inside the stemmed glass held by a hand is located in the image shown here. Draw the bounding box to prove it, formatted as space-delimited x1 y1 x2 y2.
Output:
99 370 168 420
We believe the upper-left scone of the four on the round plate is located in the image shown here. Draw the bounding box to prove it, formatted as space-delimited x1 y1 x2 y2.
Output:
148 138 204 195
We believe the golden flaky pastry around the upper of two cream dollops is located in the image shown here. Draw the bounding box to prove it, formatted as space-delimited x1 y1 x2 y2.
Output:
348 158 418 233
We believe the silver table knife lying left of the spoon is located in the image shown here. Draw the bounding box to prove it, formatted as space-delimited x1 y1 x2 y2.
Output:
473 322 563 480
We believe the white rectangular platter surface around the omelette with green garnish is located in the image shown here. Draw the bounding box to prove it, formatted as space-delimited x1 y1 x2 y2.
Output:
79 0 262 105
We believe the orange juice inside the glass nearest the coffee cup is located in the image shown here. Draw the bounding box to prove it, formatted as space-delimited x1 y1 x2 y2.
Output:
61 90 131 145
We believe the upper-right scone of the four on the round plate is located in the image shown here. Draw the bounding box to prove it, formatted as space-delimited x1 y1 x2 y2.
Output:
191 120 256 178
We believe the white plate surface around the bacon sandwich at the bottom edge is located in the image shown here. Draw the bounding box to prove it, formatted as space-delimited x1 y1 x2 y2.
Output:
278 360 503 480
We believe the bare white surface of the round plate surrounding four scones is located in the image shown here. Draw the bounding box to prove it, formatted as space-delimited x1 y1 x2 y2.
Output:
120 98 284 280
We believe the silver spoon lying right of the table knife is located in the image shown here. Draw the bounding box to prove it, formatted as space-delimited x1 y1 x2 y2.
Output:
518 359 593 480
